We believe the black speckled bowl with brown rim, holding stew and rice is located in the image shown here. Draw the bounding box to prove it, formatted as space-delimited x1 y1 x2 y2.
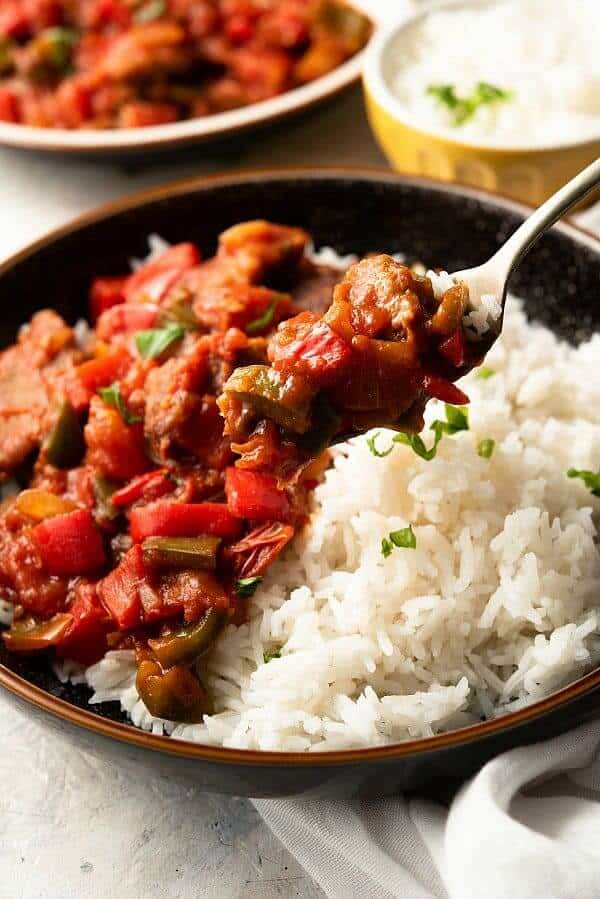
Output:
0 170 600 796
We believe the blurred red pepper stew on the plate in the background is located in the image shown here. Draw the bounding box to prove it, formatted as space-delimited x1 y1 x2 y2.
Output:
0 0 371 128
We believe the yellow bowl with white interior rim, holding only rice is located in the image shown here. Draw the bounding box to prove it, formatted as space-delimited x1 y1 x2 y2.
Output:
363 0 600 206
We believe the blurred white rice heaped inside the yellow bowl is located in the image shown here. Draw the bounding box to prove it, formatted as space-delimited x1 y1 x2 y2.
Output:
389 0 600 146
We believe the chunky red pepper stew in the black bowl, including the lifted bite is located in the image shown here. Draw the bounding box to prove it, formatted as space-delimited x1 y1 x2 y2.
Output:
0 221 481 722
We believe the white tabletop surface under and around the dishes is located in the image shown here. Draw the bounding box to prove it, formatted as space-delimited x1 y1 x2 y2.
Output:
0 90 385 899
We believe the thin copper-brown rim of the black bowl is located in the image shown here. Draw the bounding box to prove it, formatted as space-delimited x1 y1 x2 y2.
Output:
0 166 600 767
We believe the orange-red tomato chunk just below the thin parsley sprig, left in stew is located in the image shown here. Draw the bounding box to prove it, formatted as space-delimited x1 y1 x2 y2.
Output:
84 396 150 481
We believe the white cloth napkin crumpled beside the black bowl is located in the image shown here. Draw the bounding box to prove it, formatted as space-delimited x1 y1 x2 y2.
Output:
255 722 600 899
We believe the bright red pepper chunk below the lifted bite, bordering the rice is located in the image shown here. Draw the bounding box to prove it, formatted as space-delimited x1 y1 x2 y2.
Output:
225 467 291 521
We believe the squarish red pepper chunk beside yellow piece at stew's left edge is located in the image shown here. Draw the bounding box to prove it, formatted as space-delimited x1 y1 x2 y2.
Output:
33 509 106 575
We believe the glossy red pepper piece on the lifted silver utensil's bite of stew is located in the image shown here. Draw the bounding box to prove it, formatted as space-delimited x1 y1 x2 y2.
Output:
269 312 352 385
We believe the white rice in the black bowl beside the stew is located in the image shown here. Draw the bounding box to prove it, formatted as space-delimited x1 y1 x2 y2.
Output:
77 284 600 751
